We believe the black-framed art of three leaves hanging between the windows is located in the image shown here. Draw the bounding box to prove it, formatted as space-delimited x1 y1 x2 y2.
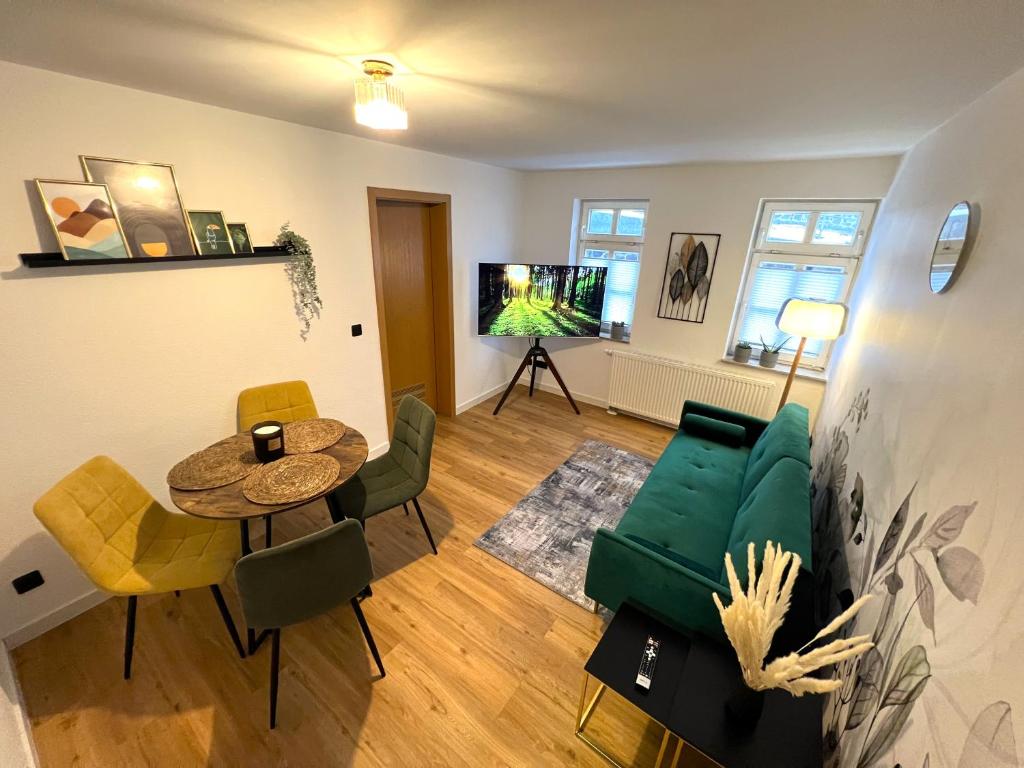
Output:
657 232 722 323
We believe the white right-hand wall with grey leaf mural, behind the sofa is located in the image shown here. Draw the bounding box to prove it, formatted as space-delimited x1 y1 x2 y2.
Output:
815 71 1024 768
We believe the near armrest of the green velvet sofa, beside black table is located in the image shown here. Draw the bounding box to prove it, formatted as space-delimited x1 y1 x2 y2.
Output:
584 528 731 639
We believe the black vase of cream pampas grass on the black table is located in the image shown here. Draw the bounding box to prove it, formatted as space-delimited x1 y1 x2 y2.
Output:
712 542 874 723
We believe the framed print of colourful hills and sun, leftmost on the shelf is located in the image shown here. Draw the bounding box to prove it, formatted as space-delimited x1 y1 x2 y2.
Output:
36 178 131 261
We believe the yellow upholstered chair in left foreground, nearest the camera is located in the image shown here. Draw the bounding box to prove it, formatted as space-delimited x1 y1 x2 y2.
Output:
35 456 245 680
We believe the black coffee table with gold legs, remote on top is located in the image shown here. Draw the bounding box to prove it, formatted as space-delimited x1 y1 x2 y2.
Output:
577 605 822 768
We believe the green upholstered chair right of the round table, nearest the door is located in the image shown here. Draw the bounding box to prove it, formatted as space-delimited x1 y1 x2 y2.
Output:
328 395 437 555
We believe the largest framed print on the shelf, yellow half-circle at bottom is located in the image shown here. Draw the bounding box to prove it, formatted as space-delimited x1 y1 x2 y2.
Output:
80 156 196 258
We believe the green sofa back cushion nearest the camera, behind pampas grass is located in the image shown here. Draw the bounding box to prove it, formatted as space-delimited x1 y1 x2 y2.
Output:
721 458 811 587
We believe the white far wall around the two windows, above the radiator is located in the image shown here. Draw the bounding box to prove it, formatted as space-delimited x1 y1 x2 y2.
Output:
520 157 899 428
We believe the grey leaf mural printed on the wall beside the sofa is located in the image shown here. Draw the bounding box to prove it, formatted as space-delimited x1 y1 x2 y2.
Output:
812 389 1020 768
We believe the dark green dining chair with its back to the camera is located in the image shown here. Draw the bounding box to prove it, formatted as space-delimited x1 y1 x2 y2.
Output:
234 520 384 728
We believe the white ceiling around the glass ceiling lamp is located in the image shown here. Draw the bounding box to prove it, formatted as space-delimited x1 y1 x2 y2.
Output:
0 0 1024 169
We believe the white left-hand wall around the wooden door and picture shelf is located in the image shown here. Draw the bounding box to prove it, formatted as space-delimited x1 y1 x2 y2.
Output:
0 63 521 639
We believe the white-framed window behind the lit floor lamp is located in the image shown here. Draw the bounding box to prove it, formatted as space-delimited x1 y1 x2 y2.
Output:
727 201 878 370
